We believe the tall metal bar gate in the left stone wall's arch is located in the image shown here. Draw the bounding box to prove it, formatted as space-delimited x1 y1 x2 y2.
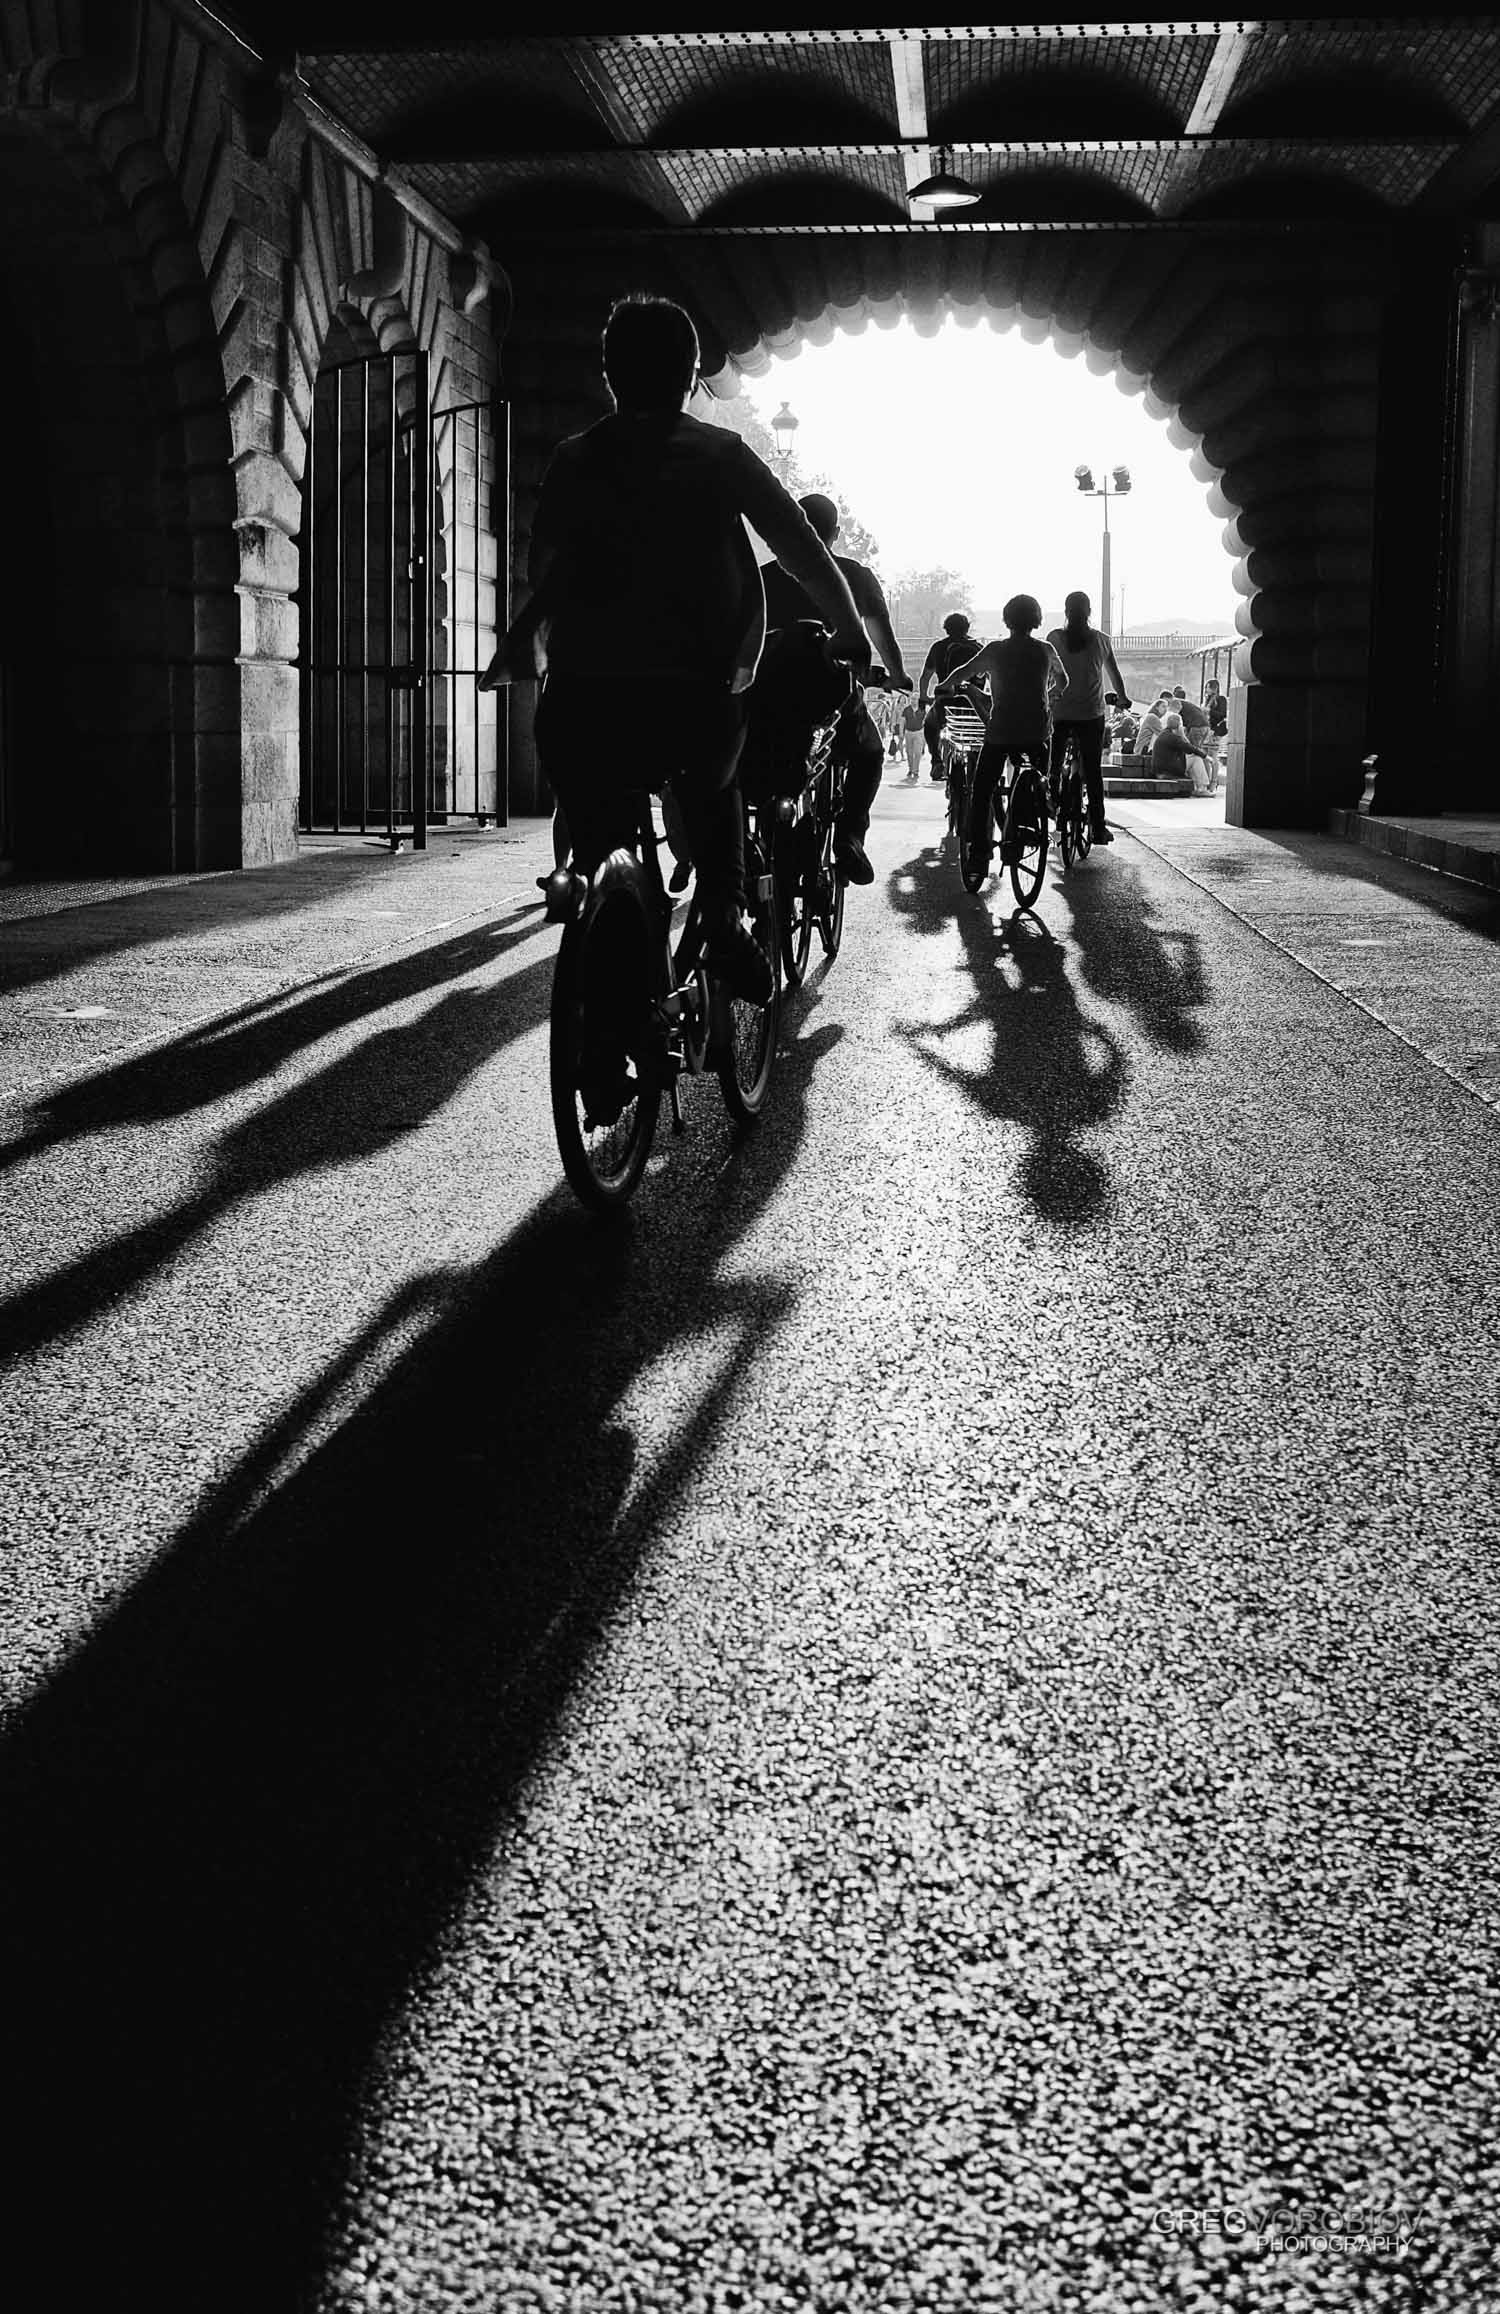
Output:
301 352 509 849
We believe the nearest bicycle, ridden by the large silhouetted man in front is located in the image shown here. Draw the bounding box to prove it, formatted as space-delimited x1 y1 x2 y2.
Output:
549 789 780 1213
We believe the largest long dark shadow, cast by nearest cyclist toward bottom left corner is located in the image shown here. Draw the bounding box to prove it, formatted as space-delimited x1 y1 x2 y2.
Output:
0 1013 829 2314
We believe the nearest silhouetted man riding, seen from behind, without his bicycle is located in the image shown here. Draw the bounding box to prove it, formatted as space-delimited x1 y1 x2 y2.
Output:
481 299 870 1027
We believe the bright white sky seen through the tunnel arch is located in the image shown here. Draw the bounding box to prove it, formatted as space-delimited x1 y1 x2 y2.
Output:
745 317 1238 634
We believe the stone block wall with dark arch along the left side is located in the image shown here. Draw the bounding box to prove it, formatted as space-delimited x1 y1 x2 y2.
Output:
0 0 498 870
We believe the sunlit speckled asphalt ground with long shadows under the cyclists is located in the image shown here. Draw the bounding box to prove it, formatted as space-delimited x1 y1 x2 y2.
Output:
0 784 1500 2314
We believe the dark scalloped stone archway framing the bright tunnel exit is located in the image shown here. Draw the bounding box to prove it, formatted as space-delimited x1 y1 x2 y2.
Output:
507 227 1394 826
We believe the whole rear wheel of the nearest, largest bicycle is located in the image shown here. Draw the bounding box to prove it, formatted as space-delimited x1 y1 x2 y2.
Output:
549 861 662 1213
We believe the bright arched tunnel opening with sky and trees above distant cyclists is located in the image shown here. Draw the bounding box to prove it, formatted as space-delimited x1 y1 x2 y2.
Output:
722 303 1255 694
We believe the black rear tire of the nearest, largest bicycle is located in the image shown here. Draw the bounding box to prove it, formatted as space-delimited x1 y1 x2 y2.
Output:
549 858 662 1213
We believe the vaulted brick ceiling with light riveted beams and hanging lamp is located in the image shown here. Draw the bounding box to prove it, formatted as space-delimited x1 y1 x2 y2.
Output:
227 13 1500 250
